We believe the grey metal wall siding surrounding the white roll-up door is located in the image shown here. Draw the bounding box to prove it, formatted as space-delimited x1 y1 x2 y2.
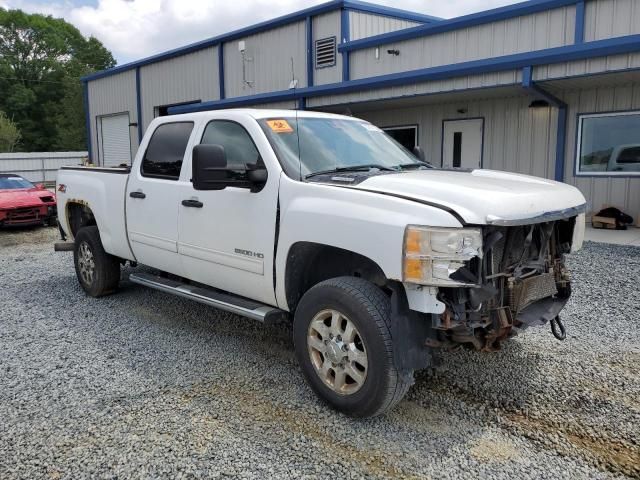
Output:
88 70 138 163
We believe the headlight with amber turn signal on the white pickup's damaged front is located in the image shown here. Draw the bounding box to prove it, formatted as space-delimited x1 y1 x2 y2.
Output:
403 225 482 287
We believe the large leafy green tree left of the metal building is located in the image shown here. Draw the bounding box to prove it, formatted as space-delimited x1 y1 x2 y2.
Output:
0 8 115 151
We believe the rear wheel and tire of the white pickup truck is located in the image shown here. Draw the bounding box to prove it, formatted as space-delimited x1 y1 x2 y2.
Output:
73 225 120 297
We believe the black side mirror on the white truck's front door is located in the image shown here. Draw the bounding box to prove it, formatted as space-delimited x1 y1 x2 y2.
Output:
191 145 229 190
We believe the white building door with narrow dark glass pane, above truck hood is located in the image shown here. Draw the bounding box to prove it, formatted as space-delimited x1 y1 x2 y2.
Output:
442 118 484 169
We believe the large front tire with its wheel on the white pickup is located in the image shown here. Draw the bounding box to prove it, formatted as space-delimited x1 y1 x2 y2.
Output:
293 277 411 417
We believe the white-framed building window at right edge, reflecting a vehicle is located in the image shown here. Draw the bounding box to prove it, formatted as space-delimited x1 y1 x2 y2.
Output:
576 112 640 176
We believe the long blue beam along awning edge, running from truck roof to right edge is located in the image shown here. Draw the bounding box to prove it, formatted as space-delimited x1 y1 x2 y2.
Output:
169 35 640 114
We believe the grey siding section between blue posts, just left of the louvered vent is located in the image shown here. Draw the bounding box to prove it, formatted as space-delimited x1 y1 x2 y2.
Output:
224 22 307 98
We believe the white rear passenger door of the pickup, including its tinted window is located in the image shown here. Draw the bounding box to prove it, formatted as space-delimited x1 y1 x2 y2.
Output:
126 122 194 275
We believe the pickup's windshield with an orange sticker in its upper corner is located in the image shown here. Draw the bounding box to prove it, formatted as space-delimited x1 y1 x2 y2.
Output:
259 117 427 178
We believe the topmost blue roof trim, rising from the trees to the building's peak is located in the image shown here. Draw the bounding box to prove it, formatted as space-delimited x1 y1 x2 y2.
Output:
81 0 437 82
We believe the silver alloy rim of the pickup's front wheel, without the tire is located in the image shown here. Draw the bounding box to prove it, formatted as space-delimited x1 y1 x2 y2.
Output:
307 310 368 395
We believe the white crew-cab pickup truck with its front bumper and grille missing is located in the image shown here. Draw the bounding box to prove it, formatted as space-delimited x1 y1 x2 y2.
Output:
56 110 585 416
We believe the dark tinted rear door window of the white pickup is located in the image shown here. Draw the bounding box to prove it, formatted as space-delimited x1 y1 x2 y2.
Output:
140 122 193 180
